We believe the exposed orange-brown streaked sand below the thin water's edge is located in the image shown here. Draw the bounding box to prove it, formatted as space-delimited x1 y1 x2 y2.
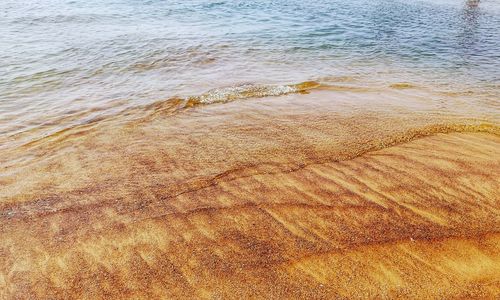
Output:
0 133 500 299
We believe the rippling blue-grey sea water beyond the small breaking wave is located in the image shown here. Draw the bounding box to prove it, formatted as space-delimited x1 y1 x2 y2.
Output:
0 0 500 136
